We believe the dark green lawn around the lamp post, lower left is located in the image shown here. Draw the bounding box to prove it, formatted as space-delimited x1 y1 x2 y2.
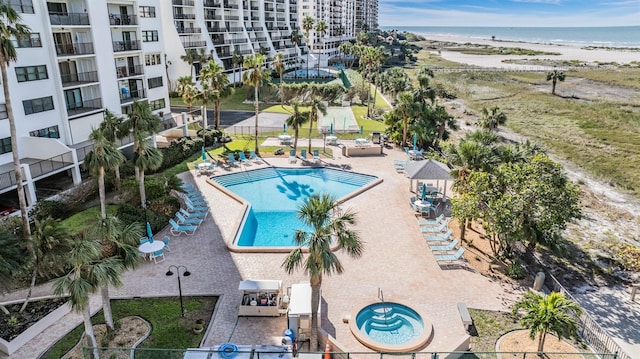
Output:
43 297 218 359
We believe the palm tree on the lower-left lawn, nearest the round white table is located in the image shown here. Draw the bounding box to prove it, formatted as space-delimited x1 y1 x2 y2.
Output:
91 216 144 331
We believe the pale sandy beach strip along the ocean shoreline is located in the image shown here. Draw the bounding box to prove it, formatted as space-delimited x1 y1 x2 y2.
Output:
412 34 640 68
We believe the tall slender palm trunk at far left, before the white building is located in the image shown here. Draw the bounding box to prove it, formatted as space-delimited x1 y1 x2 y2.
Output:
0 58 37 311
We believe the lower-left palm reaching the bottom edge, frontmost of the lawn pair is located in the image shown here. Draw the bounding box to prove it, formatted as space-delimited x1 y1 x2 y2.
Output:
53 238 124 359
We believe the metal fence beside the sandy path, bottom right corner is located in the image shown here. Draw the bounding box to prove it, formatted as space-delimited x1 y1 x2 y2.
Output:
545 273 631 359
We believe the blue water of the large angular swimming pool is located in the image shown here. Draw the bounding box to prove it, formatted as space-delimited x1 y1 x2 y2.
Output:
211 167 377 247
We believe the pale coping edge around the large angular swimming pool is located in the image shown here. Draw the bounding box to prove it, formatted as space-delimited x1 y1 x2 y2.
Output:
206 166 383 253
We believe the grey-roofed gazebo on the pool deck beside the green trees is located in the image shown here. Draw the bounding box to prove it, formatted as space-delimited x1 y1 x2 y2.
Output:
404 159 453 197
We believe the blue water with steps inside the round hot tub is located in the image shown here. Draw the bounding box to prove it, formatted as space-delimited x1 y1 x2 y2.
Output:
356 302 424 344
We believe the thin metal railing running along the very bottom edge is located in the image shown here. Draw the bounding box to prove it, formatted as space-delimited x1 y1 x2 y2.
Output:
83 346 618 359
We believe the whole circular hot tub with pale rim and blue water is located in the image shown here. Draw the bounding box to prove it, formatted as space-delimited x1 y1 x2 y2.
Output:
349 302 433 352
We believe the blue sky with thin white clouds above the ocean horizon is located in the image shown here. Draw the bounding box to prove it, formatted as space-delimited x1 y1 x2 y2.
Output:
378 0 640 27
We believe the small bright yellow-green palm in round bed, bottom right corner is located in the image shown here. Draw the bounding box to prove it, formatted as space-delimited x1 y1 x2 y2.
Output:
512 292 582 355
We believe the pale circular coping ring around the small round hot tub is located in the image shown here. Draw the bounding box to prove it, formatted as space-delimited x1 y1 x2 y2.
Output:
349 300 434 353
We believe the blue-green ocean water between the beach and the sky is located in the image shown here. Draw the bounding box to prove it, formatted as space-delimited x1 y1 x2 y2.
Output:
380 26 640 47
